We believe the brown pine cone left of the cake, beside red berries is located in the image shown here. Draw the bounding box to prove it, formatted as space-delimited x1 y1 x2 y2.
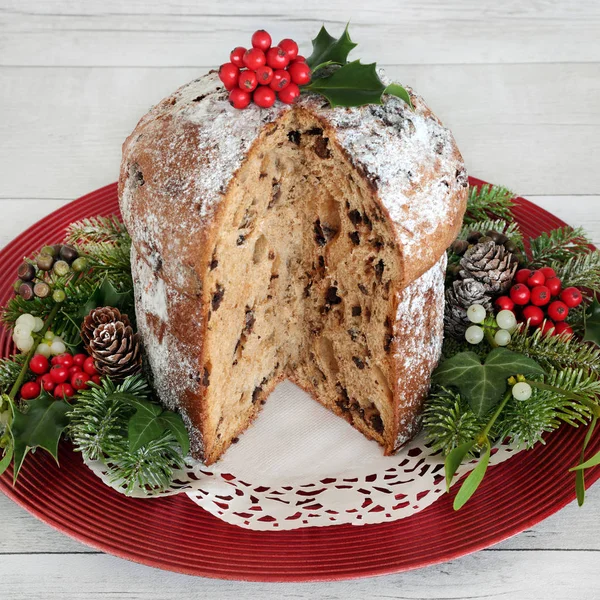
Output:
89 321 142 380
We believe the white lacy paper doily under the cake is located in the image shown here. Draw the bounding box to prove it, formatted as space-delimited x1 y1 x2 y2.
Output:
87 382 517 531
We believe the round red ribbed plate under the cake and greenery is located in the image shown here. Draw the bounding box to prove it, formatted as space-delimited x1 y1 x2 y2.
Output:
0 179 600 581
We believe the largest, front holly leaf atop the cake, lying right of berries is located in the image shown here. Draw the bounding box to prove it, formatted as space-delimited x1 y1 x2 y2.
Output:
305 60 385 107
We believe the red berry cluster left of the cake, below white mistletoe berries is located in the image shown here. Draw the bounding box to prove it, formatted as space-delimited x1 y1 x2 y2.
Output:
19 352 100 400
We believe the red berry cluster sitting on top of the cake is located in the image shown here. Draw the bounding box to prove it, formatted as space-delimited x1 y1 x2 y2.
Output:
219 29 310 109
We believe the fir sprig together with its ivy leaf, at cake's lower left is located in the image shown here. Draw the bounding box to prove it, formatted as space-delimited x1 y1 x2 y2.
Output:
69 375 189 493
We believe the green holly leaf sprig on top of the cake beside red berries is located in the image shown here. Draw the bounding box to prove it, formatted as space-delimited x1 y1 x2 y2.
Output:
304 26 412 108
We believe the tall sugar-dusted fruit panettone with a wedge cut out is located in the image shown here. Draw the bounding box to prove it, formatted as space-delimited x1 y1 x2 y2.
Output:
120 73 467 464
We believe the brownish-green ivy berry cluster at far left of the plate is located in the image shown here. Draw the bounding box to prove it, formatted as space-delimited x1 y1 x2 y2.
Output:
13 244 87 302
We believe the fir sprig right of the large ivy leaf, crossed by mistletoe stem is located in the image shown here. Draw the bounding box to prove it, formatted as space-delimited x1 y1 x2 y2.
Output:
493 368 600 448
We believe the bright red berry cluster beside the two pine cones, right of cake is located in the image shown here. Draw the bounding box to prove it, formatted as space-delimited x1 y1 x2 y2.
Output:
496 267 583 335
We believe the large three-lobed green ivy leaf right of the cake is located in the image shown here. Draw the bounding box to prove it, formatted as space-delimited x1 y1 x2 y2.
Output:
433 348 545 417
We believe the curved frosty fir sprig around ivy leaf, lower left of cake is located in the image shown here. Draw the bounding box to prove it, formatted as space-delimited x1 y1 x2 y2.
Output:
69 375 184 493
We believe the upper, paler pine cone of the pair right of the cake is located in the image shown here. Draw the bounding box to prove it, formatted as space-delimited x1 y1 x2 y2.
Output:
460 241 518 294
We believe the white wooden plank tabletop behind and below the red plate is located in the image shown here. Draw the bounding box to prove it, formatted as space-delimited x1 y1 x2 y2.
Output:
0 0 600 600
